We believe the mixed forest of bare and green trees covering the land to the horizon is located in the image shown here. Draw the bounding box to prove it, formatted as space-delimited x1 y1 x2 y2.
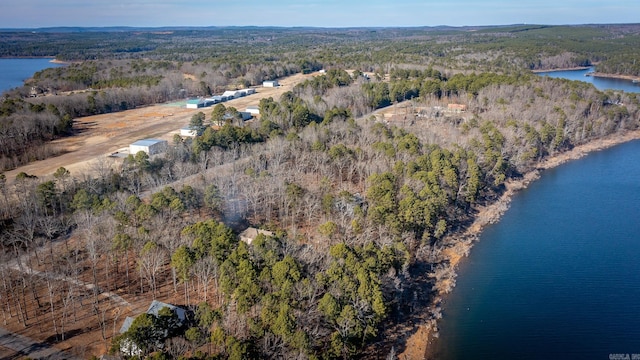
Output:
0 25 640 359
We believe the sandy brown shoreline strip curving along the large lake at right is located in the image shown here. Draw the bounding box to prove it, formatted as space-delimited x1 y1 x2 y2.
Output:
418 129 640 359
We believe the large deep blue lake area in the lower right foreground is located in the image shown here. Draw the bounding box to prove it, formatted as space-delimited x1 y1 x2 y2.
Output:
436 141 640 359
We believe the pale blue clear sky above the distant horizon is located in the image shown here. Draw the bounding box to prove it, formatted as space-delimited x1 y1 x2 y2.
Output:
0 0 640 28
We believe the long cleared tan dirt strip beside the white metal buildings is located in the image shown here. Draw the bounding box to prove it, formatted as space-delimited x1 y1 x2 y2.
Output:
5 73 318 183
